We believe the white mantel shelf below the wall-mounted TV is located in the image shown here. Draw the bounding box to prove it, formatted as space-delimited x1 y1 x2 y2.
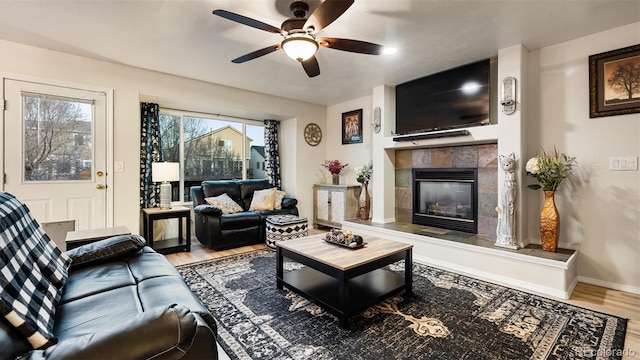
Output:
383 124 499 150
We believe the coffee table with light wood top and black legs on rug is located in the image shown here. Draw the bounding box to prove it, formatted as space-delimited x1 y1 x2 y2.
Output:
276 234 413 327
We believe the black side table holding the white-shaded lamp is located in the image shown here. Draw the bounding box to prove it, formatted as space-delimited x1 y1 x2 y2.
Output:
142 206 191 254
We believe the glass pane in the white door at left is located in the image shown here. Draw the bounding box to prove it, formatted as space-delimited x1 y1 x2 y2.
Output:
22 94 93 182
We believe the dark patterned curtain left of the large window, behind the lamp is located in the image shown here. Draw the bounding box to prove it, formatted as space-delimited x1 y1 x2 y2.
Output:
140 103 162 209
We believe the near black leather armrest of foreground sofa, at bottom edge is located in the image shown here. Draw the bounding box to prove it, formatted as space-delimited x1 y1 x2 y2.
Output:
24 304 197 360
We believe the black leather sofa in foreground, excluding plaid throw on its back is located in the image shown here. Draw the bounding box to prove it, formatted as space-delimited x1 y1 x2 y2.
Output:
0 235 218 359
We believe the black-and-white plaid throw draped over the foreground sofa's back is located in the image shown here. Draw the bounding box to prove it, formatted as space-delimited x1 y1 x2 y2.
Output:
0 192 71 349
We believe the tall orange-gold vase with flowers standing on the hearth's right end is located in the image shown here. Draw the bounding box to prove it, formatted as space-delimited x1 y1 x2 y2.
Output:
525 148 576 252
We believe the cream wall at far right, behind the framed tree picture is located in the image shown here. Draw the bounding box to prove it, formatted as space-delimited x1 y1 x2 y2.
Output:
528 23 640 292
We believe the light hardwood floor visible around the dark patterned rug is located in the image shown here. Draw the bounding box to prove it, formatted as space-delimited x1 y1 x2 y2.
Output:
167 238 640 360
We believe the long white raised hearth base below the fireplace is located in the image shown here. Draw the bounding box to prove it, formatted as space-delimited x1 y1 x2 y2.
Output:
342 220 578 299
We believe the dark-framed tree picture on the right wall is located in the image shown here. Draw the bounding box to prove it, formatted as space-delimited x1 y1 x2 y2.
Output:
589 44 640 118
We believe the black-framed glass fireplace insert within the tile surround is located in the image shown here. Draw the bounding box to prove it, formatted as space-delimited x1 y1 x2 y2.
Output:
413 168 478 234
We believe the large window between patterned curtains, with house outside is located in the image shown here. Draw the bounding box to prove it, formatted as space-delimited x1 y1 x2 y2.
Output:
159 109 265 201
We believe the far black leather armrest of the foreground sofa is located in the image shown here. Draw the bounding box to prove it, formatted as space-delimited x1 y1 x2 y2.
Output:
66 235 147 268
